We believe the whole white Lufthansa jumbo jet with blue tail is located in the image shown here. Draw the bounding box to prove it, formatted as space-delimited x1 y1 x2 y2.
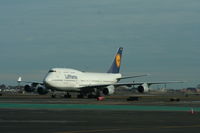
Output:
18 47 183 98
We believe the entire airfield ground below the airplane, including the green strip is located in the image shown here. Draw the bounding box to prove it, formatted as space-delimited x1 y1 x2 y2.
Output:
0 96 200 133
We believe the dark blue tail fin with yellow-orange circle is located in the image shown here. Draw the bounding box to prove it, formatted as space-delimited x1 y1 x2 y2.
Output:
107 47 123 73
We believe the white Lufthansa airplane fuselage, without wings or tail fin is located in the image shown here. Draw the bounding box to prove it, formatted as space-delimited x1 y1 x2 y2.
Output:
44 68 121 91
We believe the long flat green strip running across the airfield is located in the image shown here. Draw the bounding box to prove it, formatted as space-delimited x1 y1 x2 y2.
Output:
0 103 200 112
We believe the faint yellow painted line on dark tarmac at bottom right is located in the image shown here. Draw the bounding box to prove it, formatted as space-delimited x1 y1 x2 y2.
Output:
57 125 200 133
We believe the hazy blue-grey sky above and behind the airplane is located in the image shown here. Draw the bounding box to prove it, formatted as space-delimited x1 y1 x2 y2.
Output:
0 0 200 88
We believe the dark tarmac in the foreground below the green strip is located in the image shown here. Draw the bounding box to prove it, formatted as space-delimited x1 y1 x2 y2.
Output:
0 109 200 133
